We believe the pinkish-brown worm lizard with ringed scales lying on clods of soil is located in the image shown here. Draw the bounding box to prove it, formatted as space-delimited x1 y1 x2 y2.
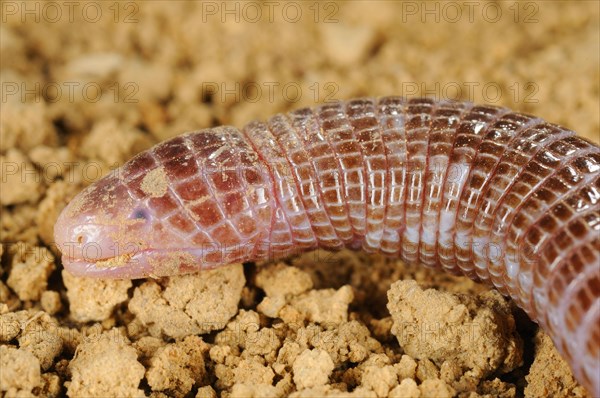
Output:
55 97 600 395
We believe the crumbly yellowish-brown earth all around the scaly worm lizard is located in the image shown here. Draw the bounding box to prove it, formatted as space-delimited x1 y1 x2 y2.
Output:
0 0 600 397
